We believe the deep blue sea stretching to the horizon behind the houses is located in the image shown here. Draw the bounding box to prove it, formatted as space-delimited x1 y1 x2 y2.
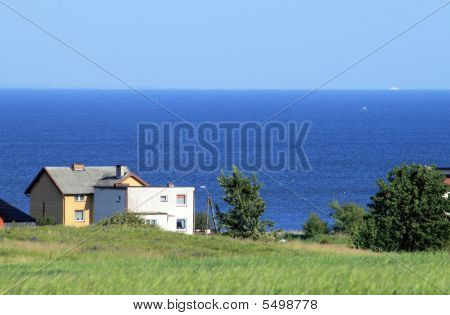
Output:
0 90 450 229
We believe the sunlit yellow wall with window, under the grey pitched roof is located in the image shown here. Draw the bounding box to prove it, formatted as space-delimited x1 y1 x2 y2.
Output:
64 194 94 227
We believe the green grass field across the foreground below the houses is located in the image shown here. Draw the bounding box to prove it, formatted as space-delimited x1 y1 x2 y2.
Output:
0 226 450 294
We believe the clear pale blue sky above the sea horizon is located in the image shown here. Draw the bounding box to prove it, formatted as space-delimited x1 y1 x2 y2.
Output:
0 0 450 89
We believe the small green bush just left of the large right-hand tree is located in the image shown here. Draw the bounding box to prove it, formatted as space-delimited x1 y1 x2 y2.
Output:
330 200 366 234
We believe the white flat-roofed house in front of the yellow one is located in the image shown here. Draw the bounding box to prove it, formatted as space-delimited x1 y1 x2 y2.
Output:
94 183 195 234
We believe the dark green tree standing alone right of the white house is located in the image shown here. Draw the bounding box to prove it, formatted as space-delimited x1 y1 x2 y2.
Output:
216 166 273 238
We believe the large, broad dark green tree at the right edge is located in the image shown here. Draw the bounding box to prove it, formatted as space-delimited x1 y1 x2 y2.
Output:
353 164 450 251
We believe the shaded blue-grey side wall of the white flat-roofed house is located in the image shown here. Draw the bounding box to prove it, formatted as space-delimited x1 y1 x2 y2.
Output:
93 187 127 222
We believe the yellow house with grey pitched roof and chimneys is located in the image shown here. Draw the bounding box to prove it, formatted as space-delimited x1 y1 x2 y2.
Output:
25 164 149 227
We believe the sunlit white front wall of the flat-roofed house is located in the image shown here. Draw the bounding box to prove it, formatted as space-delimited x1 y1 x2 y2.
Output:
127 187 195 234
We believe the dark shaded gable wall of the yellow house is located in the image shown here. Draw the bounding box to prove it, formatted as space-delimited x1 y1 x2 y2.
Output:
30 172 63 224
